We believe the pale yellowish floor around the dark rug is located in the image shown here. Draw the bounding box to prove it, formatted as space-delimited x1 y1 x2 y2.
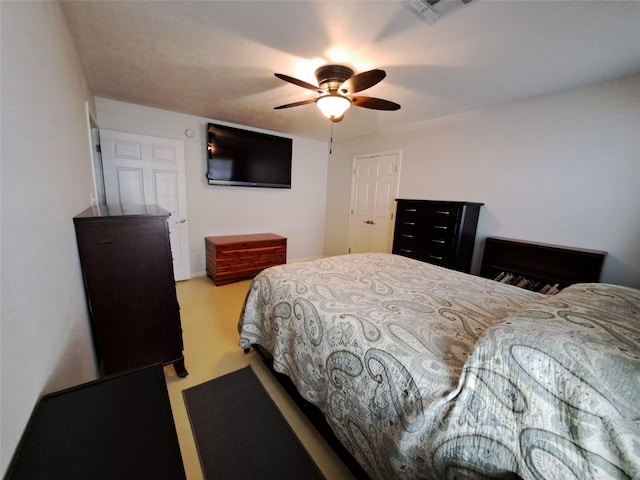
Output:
164 277 353 480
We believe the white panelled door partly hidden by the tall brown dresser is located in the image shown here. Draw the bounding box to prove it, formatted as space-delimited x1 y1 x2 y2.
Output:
100 130 191 280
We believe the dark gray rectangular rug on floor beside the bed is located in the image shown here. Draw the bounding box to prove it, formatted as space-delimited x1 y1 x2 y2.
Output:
182 366 324 480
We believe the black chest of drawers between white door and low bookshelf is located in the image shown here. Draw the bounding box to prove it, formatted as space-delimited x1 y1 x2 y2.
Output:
392 199 484 273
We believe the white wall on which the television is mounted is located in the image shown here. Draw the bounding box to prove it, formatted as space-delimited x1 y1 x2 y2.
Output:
96 98 328 276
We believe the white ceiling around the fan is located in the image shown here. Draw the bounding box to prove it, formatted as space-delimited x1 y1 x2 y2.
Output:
63 0 640 140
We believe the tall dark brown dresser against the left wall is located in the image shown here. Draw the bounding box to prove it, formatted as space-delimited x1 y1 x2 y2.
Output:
73 205 187 377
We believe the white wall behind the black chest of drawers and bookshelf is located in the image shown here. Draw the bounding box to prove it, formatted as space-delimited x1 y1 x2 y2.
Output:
325 76 640 288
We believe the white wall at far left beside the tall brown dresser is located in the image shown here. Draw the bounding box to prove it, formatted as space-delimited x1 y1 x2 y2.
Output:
0 2 96 475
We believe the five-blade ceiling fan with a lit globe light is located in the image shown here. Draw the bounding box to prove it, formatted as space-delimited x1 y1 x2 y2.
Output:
275 65 400 122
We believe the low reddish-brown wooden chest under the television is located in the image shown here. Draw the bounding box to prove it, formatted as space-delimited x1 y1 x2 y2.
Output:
205 233 287 285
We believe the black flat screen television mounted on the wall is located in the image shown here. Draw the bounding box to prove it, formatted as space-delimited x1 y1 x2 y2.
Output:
207 123 292 188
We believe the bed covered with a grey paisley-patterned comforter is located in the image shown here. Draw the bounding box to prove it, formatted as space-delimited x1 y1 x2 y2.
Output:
238 254 640 480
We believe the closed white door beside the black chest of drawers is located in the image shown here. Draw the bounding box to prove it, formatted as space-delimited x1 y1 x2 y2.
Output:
349 152 400 253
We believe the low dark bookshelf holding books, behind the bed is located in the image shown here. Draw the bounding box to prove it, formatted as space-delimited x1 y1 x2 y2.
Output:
480 237 607 295
